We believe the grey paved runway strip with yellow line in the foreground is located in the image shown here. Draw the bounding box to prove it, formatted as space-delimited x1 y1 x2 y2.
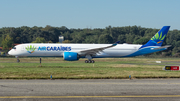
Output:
0 79 180 101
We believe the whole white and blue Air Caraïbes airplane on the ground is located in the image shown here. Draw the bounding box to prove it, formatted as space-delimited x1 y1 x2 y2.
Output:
8 26 171 63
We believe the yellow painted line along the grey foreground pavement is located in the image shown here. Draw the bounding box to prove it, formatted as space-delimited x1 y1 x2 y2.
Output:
0 95 180 99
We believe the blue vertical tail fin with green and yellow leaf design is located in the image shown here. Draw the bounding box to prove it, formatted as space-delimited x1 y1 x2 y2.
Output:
140 26 170 49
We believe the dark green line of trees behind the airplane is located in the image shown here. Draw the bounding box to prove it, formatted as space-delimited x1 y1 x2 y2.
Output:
0 25 180 57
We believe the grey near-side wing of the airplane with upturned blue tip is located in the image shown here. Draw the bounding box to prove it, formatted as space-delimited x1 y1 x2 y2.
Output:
79 41 120 55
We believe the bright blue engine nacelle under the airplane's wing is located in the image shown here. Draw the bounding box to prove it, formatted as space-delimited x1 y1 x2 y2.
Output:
63 52 79 61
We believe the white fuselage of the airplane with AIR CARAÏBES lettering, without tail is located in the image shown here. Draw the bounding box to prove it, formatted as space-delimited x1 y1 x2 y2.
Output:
8 43 142 58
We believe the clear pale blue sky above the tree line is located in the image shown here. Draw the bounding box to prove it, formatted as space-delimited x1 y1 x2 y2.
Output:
0 0 180 30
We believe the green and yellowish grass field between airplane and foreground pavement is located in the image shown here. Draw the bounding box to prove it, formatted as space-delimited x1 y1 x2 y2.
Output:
0 57 180 79
